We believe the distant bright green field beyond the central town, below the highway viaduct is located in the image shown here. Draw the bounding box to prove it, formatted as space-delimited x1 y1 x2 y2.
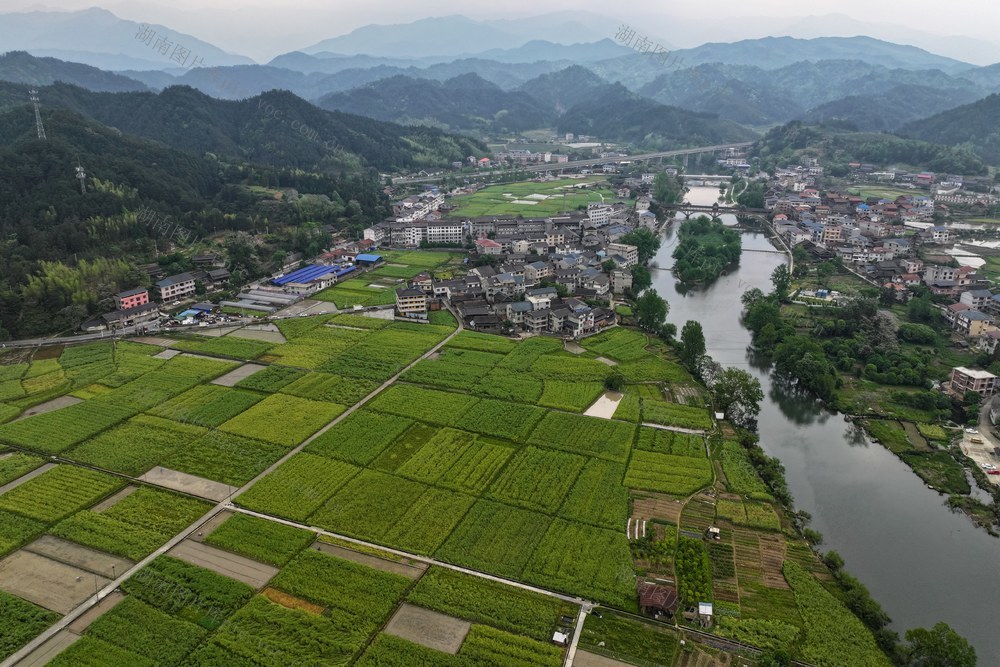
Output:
452 176 615 218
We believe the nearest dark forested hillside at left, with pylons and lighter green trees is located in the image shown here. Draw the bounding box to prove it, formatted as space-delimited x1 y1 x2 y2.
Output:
0 97 398 340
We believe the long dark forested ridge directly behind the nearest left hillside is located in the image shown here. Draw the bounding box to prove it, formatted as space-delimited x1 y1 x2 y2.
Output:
0 83 485 173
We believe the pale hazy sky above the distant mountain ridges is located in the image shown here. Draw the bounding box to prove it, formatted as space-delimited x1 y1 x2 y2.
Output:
0 0 1000 64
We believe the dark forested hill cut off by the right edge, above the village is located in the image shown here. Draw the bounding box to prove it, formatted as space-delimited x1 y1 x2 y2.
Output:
899 95 1000 165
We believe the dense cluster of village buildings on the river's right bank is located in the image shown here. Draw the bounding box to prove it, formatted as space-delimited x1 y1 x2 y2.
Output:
765 172 1000 396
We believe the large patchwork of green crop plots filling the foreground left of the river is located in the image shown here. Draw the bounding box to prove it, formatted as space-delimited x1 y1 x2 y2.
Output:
0 316 885 667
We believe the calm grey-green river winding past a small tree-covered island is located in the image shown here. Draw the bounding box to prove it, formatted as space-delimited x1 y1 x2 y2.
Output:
653 188 1000 665
